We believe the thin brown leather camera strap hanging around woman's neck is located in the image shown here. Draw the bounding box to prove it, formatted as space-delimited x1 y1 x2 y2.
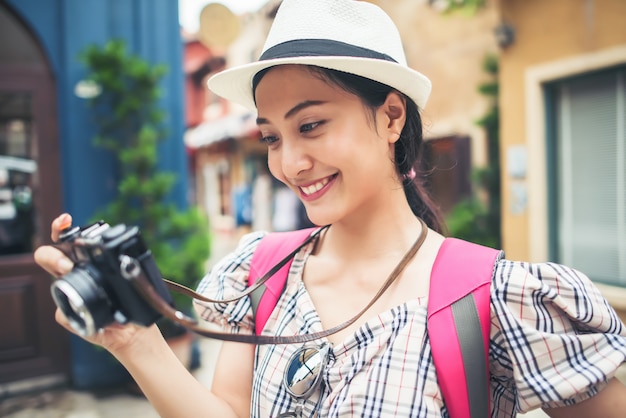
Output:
129 219 428 344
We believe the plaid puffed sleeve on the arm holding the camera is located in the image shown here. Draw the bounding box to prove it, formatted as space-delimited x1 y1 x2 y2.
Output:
194 232 266 334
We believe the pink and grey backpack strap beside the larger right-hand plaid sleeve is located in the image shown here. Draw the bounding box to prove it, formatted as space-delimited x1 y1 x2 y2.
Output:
428 238 502 418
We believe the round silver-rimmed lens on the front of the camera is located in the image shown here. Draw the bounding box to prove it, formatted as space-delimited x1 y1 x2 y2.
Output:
50 267 114 337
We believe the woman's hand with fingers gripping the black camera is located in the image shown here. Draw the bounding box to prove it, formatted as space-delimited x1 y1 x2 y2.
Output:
35 214 160 354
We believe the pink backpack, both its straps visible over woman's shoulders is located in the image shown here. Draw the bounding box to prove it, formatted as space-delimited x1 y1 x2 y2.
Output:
249 229 502 418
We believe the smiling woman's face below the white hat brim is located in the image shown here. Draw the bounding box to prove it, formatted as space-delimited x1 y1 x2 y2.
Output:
256 65 400 225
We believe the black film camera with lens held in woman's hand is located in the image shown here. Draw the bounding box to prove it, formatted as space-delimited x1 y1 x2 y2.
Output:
50 221 173 336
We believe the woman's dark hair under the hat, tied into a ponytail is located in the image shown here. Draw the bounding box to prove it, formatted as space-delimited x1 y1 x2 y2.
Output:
252 66 445 233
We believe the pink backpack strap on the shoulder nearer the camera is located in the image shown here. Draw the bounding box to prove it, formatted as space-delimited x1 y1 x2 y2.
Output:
248 228 316 335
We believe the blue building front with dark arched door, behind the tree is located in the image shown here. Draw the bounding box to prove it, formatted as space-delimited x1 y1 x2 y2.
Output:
0 0 187 393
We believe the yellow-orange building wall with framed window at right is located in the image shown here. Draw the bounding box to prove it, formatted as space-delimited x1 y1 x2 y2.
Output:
498 0 626 317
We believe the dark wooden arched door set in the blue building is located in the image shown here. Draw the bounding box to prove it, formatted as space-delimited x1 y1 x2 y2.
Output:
0 3 69 384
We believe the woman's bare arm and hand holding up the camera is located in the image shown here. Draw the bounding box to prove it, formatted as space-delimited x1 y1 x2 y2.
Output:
35 214 245 418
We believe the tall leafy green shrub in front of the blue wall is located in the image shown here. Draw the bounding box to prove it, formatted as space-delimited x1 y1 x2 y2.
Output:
78 40 210 324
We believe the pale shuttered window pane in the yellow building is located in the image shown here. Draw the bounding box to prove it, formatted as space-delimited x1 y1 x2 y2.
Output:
549 69 626 286
